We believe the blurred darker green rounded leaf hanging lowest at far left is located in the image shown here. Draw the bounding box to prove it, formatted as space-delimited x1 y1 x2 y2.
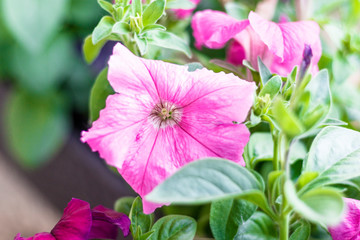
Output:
5 91 69 168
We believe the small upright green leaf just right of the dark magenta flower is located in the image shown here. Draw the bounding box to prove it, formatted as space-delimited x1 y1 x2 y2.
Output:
129 197 154 235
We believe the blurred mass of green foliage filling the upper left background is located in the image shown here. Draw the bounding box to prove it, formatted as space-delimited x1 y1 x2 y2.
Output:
0 0 104 167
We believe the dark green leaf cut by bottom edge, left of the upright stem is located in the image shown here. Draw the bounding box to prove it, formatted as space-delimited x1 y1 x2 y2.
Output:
234 212 278 240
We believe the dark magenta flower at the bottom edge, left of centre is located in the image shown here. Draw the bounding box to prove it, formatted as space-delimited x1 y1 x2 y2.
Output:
14 198 130 240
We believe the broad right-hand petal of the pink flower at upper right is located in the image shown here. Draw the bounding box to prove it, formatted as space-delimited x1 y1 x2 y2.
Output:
249 12 321 76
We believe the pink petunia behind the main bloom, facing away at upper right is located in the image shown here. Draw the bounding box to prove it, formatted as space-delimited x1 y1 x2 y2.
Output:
191 10 321 76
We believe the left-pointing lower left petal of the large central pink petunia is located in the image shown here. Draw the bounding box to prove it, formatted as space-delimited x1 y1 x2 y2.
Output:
81 94 155 168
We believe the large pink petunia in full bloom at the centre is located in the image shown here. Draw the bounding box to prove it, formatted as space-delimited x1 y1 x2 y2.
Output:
81 44 255 213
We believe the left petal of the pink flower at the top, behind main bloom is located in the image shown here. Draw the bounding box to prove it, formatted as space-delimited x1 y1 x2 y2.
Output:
191 10 249 49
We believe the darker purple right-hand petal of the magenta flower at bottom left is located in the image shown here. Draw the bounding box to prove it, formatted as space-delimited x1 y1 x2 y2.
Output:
89 205 130 239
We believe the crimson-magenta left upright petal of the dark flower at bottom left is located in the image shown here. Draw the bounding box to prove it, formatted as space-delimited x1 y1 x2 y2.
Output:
51 198 92 240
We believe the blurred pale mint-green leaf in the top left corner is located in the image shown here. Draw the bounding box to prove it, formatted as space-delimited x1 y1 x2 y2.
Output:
0 0 68 54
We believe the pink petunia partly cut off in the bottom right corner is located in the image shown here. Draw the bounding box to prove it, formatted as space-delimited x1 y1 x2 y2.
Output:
329 198 360 240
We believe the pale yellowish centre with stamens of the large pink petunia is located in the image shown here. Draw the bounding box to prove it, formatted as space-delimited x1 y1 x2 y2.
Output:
149 101 182 128
